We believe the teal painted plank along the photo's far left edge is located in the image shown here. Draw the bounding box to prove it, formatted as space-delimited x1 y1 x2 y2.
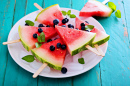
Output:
0 0 15 86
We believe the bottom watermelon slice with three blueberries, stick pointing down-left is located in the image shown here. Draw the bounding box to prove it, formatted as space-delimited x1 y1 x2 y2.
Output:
31 39 66 70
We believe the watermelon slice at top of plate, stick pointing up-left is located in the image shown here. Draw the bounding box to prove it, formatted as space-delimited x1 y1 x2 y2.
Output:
35 4 64 26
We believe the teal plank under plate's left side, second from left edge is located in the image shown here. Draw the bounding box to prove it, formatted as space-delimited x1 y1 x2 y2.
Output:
4 0 37 86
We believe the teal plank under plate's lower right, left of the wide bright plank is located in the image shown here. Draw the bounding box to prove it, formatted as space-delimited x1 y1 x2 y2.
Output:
72 0 101 86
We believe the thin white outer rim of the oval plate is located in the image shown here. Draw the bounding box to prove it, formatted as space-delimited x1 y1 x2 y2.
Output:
7 8 108 78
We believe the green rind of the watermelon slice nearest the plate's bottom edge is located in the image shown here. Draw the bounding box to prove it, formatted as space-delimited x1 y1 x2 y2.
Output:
31 49 62 70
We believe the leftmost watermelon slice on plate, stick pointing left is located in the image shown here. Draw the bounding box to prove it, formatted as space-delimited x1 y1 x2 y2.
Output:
18 26 57 51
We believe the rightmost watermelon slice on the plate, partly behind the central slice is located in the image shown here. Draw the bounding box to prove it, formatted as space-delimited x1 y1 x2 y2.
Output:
75 17 110 47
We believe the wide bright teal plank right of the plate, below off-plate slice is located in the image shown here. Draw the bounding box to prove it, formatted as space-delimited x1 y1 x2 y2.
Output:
97 0 130 86
